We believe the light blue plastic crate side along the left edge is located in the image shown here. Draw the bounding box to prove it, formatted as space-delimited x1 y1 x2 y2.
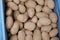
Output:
0 0 6 40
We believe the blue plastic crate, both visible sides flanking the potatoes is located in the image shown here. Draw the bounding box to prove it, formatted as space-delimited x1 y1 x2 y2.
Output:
0 0 60 40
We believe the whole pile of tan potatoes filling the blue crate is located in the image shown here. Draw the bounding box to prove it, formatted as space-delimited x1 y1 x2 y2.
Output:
6 0 59 40
